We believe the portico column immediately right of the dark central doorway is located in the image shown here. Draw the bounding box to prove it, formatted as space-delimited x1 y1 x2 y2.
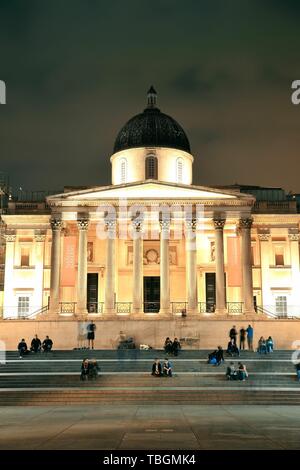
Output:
159 220 171 315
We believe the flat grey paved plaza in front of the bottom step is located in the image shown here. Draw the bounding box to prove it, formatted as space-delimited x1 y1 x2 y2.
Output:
0 405 300 450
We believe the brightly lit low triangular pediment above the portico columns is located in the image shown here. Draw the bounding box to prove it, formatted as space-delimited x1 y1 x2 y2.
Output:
48 181 252 202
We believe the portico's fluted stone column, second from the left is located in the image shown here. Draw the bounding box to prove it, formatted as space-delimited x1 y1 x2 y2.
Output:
76 218 89 315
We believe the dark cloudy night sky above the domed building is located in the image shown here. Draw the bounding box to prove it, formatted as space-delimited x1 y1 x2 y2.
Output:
0 0 300 192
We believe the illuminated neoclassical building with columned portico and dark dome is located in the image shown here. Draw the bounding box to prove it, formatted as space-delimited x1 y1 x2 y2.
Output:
0 88 300 319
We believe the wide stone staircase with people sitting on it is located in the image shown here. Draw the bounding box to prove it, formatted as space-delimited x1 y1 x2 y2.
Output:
0 350 300 406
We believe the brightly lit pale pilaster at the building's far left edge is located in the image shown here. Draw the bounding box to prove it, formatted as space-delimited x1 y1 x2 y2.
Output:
3 231 18 318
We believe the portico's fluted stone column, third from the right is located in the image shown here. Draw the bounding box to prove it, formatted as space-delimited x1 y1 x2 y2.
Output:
185 219 198 314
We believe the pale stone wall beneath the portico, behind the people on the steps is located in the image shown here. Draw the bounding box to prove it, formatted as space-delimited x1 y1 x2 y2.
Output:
0 318 300 350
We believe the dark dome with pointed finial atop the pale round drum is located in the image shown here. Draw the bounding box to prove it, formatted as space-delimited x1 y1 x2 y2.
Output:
114 87 191 153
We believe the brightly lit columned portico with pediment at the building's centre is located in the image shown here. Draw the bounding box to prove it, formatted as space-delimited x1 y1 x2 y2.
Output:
42 181 254 318
